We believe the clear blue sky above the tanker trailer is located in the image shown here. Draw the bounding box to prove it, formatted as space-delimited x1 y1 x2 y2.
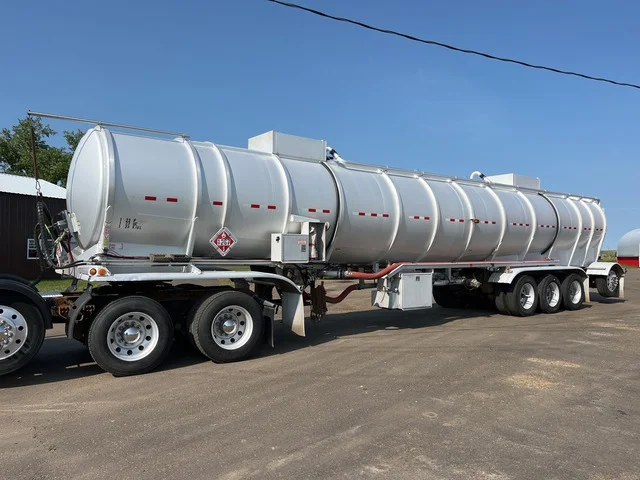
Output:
0 0 640 248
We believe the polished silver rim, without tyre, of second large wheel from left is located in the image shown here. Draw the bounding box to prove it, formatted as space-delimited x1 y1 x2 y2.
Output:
107 312 158 362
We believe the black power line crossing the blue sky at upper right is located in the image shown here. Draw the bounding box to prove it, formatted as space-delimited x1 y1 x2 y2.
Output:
267 0 640 90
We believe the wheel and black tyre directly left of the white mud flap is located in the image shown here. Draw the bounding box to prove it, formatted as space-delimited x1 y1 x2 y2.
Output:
191 290 264 363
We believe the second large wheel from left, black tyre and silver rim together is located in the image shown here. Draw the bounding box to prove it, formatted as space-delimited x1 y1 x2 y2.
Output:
88 296 173 377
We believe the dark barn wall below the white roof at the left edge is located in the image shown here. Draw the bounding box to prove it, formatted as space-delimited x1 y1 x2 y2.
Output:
0 192 66 280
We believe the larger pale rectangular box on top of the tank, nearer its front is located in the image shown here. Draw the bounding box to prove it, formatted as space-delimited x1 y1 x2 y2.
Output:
249 130 327 162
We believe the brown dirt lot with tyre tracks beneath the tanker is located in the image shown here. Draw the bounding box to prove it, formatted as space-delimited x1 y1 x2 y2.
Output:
0 270 640 480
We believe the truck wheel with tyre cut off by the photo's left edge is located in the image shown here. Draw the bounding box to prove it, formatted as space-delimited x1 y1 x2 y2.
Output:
0 293 45 376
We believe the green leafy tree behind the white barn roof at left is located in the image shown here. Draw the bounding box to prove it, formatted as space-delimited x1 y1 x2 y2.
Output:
0 117 83 187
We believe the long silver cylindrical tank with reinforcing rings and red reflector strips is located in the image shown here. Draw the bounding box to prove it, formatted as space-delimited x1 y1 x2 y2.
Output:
67 127 606 266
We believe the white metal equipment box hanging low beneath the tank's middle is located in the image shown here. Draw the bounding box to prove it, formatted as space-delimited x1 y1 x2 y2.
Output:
371 273 433 310
